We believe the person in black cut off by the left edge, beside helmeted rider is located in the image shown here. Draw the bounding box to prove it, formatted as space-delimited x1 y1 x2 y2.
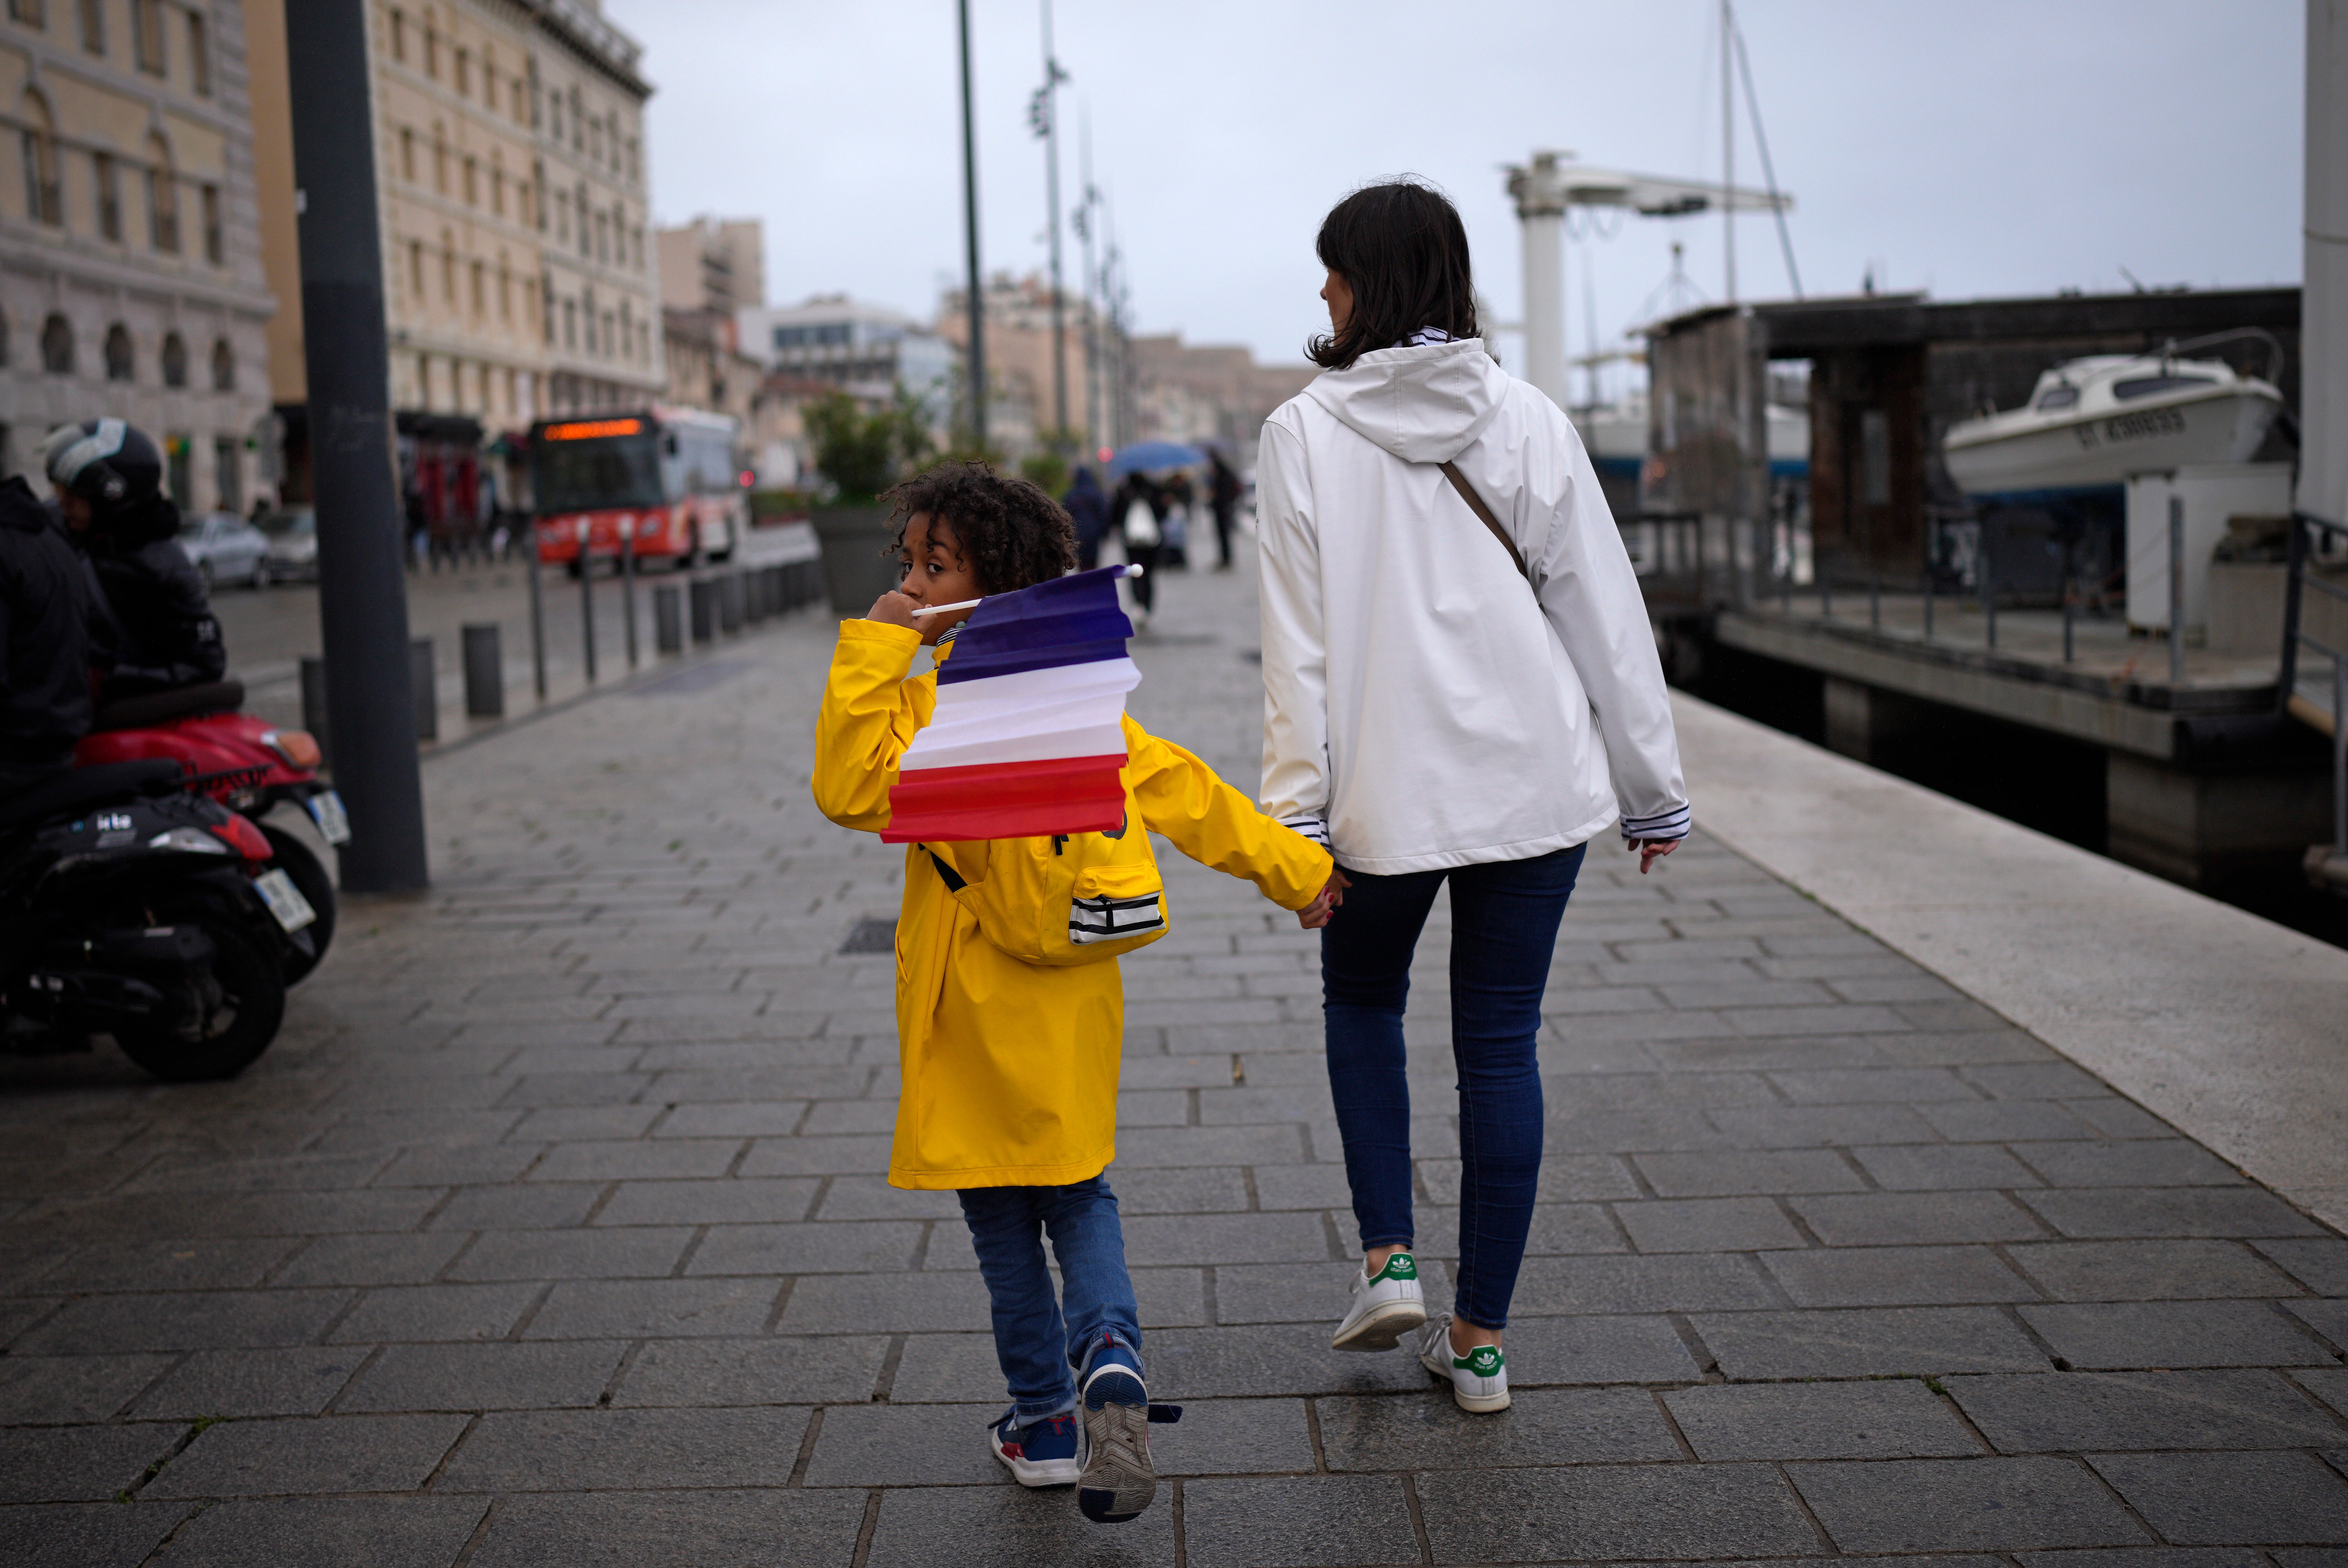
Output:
0 479 89 800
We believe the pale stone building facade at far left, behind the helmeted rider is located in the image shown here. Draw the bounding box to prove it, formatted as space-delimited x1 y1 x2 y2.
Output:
0 0 272 512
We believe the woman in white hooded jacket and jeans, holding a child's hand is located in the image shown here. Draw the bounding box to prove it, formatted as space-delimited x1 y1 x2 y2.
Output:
1256 183 1688 1411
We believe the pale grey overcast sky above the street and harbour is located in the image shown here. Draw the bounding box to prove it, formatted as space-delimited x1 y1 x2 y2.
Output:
606 0 2303 389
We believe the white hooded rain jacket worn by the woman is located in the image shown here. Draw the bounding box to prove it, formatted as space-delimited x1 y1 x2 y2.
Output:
1256 338 1688 876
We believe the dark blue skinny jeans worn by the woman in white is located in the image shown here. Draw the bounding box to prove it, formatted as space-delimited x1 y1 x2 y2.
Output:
1322 845 1587 1328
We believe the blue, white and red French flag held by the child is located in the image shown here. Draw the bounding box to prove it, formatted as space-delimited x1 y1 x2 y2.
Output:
881 566 1141 843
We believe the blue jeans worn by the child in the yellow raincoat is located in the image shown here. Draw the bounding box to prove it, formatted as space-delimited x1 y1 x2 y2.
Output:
956 1176 1141 1427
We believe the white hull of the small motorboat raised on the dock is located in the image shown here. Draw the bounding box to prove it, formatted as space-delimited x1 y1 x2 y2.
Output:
1944 387 2282 495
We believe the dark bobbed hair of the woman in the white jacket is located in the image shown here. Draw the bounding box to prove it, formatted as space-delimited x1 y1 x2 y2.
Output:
1305 176 1482 371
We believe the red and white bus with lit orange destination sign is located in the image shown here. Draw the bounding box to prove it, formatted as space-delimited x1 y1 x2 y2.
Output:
531 408 749 571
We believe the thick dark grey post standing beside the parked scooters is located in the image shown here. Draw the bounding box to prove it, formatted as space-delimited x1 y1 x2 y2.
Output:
286 0 430 892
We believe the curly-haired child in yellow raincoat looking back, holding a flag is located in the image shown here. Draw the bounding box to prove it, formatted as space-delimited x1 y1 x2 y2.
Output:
812 465 1334 1523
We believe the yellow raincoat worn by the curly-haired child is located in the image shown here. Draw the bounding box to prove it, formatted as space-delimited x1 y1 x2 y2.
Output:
812 620 1331 1188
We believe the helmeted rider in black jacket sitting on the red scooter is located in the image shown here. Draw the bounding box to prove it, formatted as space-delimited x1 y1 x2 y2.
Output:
45 420 228 702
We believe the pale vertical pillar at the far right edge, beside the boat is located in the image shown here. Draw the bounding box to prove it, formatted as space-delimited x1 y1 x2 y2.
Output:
2299 0 2348 521
